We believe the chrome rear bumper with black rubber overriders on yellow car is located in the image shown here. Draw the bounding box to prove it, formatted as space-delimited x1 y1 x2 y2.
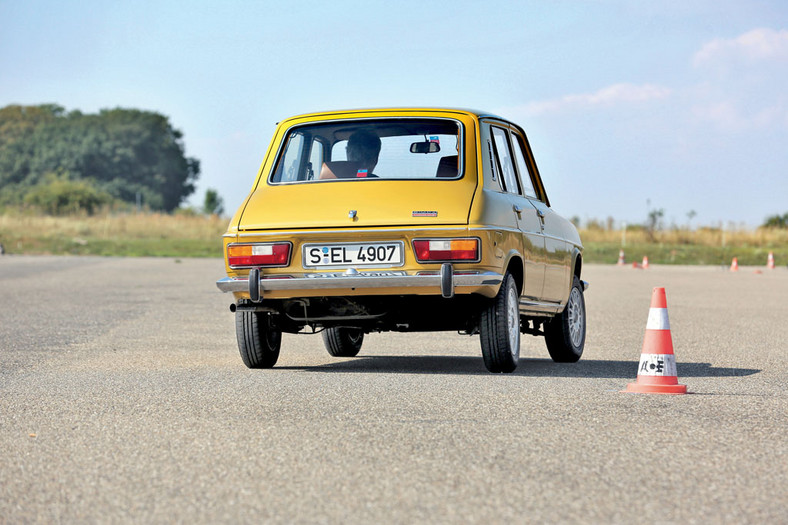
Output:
216 271 503 297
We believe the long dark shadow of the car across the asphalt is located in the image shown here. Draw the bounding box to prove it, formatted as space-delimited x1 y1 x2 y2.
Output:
275 356 760 379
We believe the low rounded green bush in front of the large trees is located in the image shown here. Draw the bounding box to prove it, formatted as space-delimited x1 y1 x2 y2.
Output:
24 176 112 215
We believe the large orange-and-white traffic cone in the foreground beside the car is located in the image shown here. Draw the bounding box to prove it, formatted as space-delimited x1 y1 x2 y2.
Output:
624 288 687 394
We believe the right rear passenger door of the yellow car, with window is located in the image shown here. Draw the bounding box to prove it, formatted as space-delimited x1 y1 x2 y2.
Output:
490 125 545 301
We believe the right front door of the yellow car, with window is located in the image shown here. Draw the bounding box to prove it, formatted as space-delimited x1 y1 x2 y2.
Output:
511 132 571 302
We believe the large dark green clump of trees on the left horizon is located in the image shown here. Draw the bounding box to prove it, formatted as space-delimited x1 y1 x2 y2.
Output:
0 104 200 211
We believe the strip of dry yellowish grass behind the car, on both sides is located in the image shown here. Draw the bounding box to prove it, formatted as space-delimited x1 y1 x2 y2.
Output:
0 213 788 266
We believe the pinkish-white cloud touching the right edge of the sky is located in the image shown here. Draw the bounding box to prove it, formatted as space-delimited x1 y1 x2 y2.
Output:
692 28 788 66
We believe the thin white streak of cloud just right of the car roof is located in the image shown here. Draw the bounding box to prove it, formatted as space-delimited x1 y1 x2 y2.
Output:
521 84 671 116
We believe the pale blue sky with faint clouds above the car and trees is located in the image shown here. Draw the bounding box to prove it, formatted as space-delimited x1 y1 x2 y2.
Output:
0 0 788 227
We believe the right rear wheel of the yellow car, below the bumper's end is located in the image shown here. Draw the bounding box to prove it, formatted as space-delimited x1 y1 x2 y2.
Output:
479 273 520 374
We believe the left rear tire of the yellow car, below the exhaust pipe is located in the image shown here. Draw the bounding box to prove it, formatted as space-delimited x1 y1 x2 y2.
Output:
235 312 282 368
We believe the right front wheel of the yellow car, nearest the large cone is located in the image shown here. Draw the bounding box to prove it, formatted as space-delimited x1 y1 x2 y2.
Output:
544 276 586 363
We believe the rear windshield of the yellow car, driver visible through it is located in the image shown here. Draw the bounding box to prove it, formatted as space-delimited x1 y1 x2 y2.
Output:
269 118 462 184
